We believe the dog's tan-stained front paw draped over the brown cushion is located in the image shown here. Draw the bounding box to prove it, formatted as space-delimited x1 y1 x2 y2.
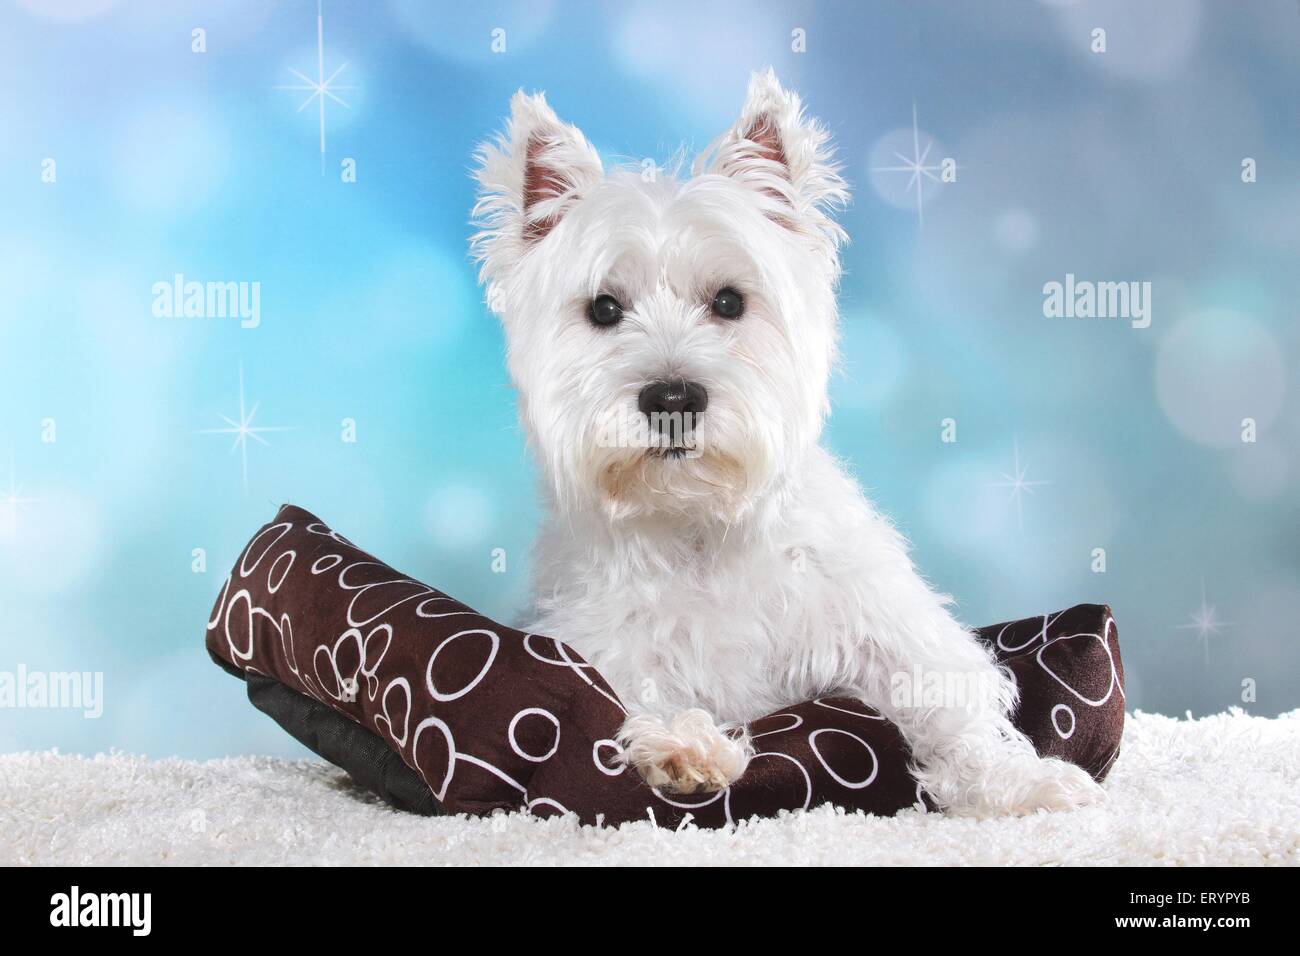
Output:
619 709 751 793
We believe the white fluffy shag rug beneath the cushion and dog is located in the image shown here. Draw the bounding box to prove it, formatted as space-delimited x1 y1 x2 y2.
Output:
0 710 1300 865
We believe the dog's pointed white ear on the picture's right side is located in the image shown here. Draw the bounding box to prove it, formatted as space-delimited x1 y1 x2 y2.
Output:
694 69 849 250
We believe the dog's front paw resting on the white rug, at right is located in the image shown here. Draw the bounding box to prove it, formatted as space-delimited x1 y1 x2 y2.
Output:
936 753 1106 817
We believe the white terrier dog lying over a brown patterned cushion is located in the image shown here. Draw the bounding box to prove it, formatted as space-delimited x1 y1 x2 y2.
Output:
473 72 1102 816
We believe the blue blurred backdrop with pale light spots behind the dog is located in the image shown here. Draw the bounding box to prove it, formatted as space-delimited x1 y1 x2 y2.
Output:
0 0 1300 757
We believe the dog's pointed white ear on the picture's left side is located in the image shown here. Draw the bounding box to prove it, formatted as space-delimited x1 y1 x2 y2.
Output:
471 90 605 299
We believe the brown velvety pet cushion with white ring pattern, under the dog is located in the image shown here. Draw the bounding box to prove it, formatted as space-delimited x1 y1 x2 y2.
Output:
207 505 1125 826
